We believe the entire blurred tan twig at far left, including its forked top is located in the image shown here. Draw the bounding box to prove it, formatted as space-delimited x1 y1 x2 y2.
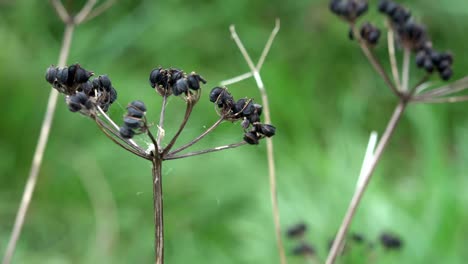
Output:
2 0 113 264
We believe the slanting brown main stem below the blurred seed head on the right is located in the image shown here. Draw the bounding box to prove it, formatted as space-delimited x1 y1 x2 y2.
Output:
326 100 407 264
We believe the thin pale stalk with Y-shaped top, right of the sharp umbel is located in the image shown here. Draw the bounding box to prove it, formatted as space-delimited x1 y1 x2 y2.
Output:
230 22 287 264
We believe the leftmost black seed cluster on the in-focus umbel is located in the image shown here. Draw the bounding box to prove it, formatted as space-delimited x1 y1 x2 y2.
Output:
45 64 117 114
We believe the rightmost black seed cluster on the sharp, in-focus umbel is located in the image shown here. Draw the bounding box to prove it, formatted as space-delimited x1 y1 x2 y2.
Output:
210 87 276 145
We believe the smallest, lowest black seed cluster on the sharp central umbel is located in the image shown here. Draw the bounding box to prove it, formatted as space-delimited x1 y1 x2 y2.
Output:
119 100 146 138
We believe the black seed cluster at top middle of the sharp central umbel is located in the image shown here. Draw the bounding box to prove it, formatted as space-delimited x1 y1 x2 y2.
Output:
149 67 206 96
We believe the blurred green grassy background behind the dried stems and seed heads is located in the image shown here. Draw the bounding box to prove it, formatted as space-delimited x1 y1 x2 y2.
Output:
0 0 468 263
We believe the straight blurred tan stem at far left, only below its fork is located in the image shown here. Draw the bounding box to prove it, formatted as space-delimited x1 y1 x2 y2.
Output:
2 24 75 264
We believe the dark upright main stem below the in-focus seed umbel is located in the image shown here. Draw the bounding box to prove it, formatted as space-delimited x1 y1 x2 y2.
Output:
152 157 164 264
